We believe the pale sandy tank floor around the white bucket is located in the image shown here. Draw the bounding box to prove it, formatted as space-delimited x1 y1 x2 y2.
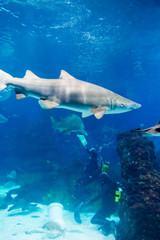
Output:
0 186 115 240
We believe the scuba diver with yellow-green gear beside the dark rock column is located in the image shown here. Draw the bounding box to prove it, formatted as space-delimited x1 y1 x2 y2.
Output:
74 135 121 236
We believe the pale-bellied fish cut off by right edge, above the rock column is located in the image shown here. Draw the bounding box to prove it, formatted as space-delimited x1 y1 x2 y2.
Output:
131 121 160 137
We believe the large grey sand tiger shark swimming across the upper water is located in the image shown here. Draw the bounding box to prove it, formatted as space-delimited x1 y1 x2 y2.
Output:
0 70 141 119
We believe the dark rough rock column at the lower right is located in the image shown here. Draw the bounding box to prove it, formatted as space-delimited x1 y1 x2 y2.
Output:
117 132 160 240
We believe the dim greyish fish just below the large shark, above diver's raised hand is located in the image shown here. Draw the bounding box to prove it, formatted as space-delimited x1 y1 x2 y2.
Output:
49 113 88 135
